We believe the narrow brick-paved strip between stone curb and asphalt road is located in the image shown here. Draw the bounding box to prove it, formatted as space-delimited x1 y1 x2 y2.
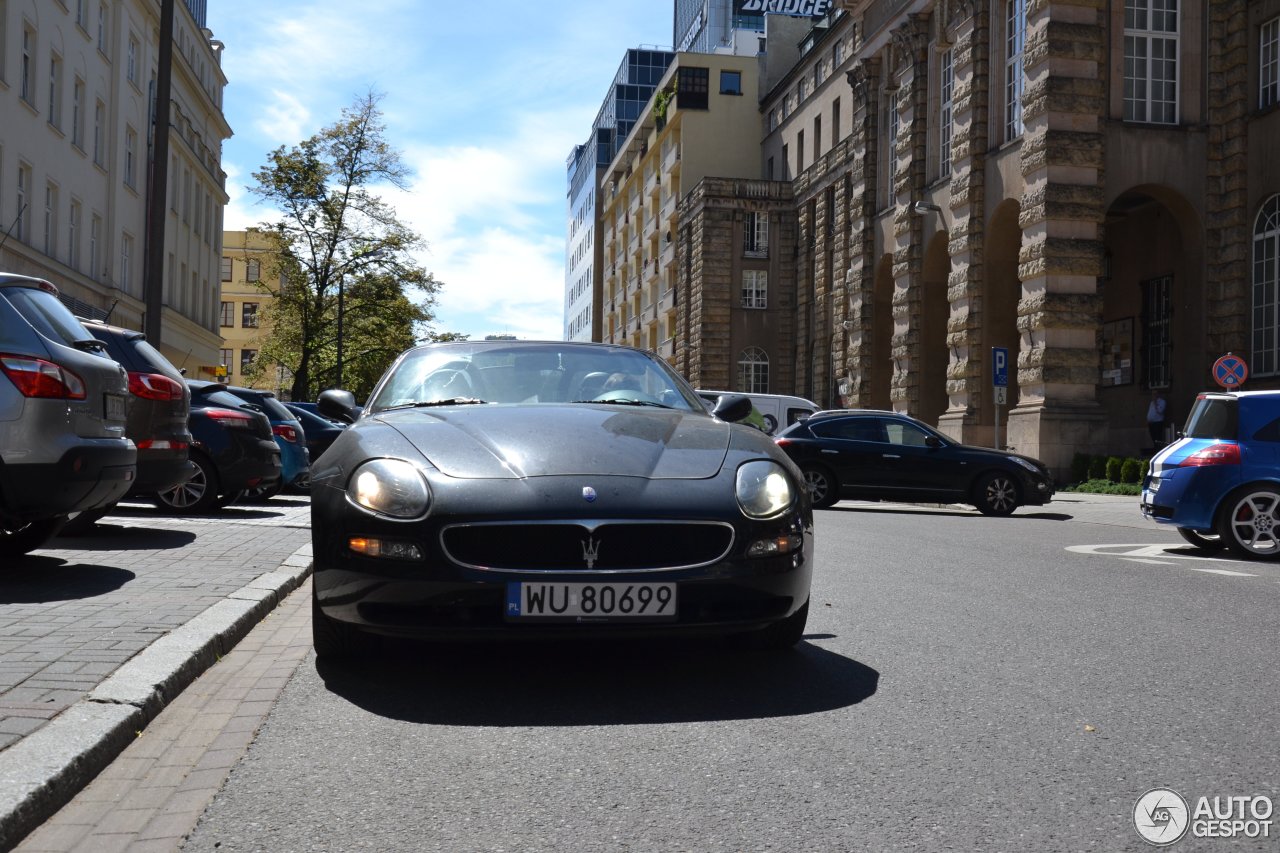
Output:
15 580 311 853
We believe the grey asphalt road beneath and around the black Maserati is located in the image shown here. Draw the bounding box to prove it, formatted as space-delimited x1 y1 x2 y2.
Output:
160 502 1280 853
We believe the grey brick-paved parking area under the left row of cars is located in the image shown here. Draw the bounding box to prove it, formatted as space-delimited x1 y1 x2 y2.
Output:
0 496 311 753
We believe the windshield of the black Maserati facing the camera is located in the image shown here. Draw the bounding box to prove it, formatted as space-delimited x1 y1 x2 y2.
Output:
366 341 705 412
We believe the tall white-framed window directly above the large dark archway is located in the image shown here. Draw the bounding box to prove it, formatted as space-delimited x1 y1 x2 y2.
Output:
1124 0 1178 124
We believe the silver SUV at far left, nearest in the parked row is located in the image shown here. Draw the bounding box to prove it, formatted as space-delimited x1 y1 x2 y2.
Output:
0 273 137 556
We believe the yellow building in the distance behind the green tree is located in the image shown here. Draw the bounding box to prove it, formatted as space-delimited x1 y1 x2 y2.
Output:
219 231 292 397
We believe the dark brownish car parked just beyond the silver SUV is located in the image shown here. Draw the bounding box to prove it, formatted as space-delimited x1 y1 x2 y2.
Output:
63 318 195 533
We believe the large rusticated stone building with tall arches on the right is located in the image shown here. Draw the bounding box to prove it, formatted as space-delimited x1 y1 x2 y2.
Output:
732 0 1280 471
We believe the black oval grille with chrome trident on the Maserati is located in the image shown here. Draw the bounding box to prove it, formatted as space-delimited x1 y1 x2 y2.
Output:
440 521 733 571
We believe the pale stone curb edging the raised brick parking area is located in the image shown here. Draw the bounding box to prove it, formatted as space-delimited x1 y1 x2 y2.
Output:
0 544 311 850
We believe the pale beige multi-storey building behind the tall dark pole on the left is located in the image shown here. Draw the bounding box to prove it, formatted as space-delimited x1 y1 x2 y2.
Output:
0 0 232 377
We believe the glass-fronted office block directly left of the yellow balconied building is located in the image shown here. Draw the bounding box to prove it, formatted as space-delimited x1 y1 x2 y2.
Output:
564 47 675 341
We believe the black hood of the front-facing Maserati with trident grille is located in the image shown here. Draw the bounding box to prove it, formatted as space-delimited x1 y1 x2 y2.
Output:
374 403 731 479
